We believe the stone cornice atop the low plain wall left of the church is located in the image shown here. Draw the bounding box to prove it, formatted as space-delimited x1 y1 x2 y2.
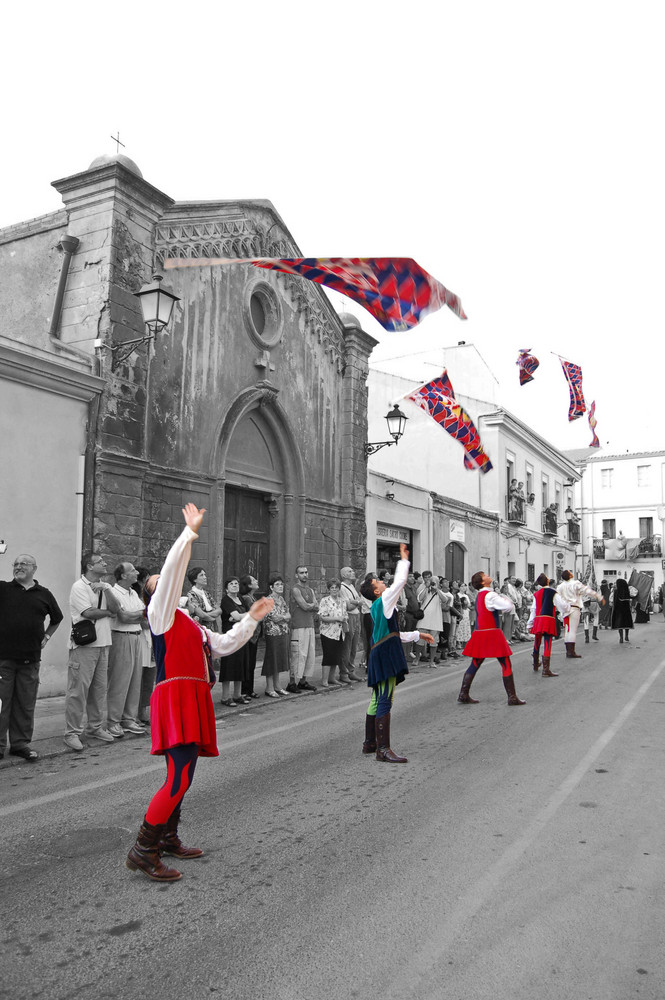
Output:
0 343 106 402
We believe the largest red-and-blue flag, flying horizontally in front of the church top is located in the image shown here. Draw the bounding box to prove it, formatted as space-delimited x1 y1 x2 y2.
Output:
164 257 466 331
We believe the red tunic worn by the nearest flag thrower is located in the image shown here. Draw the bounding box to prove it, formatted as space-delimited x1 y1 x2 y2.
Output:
150 611 219 757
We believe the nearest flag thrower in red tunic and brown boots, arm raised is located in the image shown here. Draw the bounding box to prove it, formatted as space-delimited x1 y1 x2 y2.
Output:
125 503 274 882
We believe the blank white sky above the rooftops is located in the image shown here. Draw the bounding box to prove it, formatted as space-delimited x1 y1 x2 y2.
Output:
0 0 665 451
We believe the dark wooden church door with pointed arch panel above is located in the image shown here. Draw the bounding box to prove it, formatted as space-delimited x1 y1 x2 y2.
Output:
222 406 284 594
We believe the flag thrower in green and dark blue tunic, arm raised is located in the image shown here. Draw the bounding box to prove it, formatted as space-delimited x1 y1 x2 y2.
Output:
360 544 434 764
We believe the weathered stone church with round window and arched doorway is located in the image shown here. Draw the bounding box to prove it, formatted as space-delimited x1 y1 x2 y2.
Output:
0 155 374 693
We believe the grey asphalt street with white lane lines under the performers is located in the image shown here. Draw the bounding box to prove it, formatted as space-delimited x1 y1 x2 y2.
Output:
0 621 665 1000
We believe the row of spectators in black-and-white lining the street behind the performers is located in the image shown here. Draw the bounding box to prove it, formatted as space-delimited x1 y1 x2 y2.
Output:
0 553 664 760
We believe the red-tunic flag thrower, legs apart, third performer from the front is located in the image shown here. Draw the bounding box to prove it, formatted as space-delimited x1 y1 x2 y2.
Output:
457 571 526 705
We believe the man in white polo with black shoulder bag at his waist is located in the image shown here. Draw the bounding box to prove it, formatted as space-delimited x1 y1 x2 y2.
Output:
64 553 120 751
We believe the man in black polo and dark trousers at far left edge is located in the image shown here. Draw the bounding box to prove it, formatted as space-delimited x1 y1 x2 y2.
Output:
0 555 62 761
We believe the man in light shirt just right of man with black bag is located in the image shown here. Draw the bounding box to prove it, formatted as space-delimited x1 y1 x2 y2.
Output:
106 563 148 739
